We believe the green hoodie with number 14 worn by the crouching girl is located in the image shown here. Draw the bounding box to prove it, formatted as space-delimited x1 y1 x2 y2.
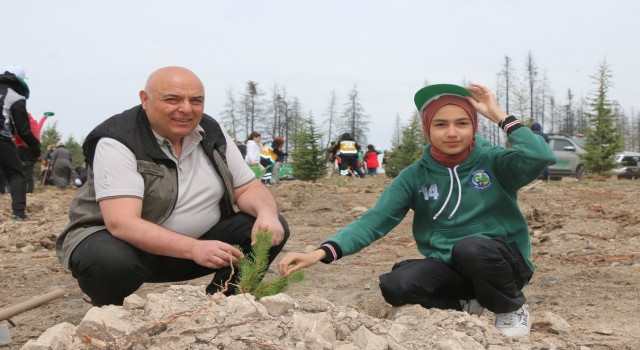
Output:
323 128 556 271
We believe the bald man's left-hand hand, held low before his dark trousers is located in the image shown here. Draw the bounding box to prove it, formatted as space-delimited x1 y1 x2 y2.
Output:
191 240 244 269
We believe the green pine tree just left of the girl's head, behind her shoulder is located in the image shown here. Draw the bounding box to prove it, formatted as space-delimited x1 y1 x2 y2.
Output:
384 112 428 177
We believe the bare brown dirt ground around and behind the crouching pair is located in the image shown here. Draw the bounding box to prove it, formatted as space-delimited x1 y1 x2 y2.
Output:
0 175 640 349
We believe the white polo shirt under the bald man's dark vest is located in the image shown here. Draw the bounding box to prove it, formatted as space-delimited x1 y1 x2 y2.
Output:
93 126 255 238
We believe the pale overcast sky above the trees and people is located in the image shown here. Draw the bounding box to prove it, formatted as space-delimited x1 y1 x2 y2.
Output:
0 0 640 149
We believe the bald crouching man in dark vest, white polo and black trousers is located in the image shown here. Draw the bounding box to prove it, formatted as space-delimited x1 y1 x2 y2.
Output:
56 67 289 306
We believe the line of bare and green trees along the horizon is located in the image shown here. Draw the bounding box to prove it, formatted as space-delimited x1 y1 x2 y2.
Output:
41 52 640 179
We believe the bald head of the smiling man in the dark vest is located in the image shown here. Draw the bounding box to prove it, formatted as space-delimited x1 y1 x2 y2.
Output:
140 67 204 145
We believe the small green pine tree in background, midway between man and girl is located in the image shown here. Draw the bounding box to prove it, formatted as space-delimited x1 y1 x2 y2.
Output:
292 117 327 181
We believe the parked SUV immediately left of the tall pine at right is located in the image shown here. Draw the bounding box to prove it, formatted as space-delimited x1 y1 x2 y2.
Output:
549 134 588 179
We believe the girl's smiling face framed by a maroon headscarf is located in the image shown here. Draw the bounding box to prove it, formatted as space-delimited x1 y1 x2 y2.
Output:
429 105 473 155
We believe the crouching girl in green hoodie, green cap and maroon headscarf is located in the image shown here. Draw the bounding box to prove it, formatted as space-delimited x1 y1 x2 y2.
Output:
278 84 555 336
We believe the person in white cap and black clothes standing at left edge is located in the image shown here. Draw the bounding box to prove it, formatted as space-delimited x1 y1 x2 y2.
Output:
0 66 40 221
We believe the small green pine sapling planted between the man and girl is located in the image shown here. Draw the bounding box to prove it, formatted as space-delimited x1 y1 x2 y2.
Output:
236 230 305 300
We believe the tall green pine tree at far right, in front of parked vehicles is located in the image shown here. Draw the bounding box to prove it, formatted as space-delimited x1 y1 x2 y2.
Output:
582 60 622 175
